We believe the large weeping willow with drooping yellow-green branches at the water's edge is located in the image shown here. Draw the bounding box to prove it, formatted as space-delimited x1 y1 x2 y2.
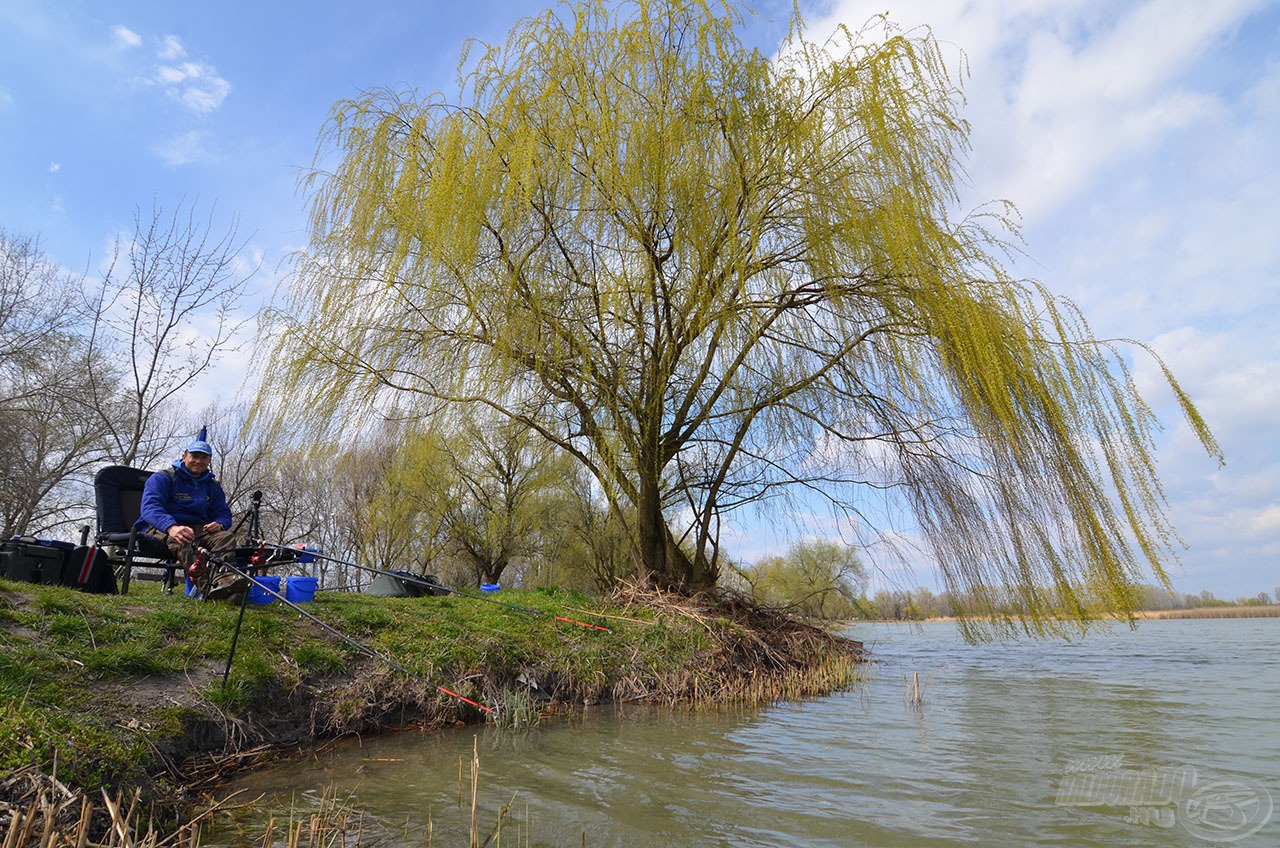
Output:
265 0 1216 635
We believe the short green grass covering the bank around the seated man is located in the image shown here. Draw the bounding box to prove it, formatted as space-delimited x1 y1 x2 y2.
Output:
0 582 657 785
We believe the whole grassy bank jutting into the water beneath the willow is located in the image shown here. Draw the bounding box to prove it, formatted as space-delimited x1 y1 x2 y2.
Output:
0 580 858 840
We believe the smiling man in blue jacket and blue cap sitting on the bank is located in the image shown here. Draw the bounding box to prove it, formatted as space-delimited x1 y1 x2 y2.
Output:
137 428 247 598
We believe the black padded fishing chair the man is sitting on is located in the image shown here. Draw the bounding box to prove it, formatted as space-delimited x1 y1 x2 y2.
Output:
93 465 182 594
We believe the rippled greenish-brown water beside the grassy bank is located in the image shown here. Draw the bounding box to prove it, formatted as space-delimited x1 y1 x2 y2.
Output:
222 619 1280 848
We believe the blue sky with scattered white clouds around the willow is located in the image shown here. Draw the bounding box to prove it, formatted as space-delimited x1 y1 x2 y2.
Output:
0 0 1280 598
